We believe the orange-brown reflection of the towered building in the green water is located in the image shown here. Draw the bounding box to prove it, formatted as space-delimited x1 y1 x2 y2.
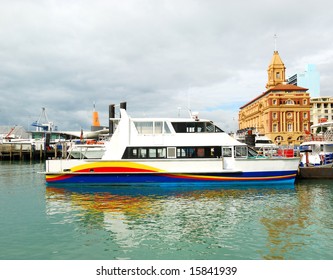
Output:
261 187 312 259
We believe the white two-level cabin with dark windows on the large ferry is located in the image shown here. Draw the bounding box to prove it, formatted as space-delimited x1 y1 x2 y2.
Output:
104 112 257 160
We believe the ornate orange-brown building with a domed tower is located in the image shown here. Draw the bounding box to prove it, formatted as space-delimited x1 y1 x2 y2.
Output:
238 50 311 145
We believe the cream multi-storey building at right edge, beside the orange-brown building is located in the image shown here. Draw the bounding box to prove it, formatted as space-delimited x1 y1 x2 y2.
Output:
310 96 333 130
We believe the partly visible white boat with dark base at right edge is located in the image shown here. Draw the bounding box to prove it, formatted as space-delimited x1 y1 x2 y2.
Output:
299 122 333 179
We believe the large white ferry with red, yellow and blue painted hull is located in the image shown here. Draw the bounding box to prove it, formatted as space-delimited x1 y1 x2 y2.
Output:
45 107 299 185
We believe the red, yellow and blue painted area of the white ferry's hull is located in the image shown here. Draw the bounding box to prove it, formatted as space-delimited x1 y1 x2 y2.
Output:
46 163 297 185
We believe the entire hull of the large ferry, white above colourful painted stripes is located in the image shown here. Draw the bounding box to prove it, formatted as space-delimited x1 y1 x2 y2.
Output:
46 158 299 184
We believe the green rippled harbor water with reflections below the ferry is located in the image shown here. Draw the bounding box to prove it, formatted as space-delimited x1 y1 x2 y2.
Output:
0 162 333 260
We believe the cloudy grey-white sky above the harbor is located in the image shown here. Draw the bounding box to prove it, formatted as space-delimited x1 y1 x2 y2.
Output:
0 0 333 131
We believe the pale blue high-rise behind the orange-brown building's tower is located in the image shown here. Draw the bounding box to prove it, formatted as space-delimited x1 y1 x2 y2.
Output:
288 64 320 97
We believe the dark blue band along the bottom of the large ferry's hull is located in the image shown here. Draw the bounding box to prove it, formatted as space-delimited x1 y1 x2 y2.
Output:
48 171 296 185
